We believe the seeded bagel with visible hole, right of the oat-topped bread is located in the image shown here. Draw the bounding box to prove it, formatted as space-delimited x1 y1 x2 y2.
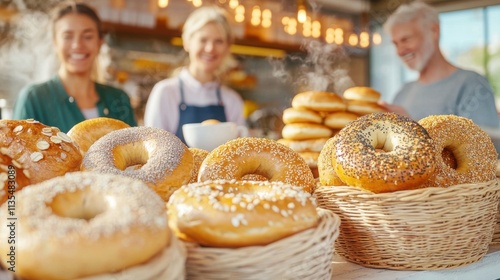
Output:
82 126 194 201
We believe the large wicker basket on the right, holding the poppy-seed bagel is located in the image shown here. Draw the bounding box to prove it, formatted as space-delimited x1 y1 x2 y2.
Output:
316 180 500 270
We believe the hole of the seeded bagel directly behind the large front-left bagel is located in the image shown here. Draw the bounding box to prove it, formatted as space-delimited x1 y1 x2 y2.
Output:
113 140 152 170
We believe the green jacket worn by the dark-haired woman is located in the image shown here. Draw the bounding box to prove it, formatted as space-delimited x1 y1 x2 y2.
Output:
12 75 137 132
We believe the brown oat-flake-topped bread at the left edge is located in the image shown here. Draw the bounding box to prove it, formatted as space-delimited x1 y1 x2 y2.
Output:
0 120 82 203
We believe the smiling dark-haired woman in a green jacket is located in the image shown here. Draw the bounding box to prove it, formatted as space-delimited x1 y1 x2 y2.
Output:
13 1 137 132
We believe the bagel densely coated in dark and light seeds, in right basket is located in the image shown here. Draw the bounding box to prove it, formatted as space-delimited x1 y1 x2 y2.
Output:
332 113 437 193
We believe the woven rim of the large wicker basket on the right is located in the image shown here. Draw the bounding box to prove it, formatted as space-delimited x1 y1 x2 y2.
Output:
315 178 500 201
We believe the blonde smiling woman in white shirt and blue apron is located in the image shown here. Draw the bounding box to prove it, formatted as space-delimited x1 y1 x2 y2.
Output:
144 6 245 141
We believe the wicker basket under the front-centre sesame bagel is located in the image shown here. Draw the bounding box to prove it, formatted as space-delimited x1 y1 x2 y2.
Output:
186 209 340 280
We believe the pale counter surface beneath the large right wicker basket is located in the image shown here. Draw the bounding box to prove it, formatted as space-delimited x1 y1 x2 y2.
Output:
332 244 500 280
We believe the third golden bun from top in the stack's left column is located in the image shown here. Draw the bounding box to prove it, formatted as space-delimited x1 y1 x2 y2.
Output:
281 123 333 140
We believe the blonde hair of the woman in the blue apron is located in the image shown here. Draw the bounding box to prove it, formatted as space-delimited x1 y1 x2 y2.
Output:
182 6 233 44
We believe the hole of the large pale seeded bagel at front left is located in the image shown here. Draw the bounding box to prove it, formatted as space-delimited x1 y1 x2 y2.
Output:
47 187 108 221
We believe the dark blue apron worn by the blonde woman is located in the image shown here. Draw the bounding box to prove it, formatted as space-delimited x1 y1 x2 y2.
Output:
175 78 226 143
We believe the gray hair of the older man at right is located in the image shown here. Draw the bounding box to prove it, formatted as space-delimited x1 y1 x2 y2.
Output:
384 1 439 34
